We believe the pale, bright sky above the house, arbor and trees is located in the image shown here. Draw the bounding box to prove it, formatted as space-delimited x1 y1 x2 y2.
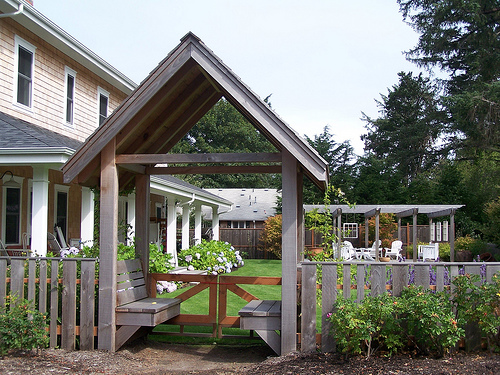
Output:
34 0 418 154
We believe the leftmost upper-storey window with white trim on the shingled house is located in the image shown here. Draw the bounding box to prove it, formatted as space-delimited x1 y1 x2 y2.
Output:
14 36 36 108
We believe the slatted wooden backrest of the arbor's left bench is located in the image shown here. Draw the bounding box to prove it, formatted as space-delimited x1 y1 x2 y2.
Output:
116 259 148 306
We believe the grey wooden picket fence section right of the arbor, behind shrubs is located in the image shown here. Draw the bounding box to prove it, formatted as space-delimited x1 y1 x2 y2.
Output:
301 262 500 352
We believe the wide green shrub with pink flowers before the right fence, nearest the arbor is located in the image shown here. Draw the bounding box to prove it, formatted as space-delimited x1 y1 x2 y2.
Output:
327 286 465 357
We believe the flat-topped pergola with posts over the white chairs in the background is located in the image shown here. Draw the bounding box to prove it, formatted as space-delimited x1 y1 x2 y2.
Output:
304 204 463 262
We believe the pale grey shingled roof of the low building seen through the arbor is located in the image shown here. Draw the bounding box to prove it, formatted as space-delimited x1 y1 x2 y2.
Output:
206 189 280 221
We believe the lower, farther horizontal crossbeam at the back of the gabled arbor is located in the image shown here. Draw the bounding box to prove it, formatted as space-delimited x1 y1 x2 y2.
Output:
146 165 281 175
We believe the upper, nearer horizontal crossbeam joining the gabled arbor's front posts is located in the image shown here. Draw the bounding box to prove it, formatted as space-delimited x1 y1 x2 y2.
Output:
116 152 281 165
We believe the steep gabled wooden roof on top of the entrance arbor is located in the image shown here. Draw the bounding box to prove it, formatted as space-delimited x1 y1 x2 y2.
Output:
63 33 328 191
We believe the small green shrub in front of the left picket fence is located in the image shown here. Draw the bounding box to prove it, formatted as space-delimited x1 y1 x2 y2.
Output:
0 296 49 356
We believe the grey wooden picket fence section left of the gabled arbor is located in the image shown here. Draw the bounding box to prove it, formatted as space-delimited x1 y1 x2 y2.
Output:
0 257 97 350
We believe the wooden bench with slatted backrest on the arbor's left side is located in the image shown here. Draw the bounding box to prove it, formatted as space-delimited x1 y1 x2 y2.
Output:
115 259 181 350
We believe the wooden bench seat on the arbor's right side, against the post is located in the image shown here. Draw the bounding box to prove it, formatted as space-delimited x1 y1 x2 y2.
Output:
238 300 281 355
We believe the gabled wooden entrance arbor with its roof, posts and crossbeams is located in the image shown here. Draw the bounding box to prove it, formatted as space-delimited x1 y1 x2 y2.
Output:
63 33 328 354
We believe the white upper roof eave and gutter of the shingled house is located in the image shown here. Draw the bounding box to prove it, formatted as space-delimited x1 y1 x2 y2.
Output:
0 0 137 94
